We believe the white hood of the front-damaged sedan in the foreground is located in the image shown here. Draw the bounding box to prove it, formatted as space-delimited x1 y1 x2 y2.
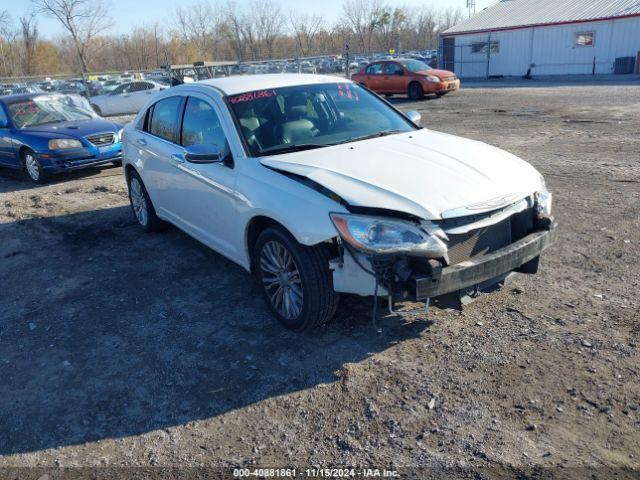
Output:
260 129 542 220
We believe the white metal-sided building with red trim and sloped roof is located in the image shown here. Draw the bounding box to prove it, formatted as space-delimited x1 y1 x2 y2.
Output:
440 0 640 78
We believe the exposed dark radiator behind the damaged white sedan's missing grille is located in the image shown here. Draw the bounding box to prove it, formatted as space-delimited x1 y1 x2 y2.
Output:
448 218 511 265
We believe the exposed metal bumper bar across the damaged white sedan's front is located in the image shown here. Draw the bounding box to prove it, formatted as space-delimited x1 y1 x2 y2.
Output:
413 222 557 300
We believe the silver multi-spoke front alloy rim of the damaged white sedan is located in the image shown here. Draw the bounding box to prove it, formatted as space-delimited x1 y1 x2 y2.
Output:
260 240 304 320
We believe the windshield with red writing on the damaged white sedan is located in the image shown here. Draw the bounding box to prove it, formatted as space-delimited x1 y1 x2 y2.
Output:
227 83 417 156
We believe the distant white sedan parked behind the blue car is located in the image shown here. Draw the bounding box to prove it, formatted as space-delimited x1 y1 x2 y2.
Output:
90 80 169 116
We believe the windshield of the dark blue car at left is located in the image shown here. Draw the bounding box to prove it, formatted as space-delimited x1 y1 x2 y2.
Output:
7 95 97 128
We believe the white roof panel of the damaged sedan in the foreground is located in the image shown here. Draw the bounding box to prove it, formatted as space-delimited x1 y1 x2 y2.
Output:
198 73 351 95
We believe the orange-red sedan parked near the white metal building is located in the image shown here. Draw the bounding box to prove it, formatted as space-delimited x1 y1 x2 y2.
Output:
351 58 460 100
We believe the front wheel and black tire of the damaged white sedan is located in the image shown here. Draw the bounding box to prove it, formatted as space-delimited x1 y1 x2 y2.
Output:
254 226 339 332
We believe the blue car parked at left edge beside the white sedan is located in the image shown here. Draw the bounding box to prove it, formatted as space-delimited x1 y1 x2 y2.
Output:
0 93 122 183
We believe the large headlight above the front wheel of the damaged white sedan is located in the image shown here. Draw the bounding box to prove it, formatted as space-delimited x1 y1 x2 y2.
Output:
330 213 447 257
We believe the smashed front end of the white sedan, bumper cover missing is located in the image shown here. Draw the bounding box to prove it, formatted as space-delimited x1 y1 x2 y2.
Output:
331 190 556 320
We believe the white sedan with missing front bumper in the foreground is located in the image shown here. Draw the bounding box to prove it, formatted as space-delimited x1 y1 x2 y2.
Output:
123 74 556 330
